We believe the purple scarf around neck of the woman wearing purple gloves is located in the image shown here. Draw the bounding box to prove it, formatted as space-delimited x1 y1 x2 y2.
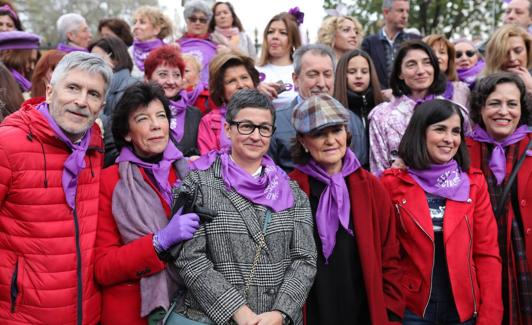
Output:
116 140 183 206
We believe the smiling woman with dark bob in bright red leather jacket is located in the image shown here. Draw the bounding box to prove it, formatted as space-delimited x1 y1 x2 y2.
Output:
382 99 502 325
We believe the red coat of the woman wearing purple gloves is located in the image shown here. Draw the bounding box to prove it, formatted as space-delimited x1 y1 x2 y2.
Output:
95 164 176 325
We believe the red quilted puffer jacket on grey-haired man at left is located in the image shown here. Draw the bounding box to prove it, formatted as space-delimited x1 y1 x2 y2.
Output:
0 104 103 325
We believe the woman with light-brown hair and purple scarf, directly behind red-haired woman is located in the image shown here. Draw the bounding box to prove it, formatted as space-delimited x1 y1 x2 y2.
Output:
129 6 173 80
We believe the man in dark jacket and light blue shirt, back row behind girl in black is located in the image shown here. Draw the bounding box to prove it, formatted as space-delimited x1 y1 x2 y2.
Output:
362 0 421 89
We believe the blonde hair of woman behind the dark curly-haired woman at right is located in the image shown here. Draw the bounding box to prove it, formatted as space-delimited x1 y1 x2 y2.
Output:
482 24 532 76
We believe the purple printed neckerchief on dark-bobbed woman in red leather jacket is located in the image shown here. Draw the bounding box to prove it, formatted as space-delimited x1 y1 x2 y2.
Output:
407 159 470 202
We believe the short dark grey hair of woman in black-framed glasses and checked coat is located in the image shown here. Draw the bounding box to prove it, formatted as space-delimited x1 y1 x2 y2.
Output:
225 89 275 124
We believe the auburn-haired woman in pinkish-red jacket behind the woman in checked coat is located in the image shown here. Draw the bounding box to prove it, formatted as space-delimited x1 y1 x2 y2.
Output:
198 52 259 155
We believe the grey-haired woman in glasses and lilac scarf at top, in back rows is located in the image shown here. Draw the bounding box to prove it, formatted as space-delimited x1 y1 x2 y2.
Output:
177 0 217 84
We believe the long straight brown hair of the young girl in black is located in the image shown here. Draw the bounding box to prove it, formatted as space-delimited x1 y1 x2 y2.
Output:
333 49 384 107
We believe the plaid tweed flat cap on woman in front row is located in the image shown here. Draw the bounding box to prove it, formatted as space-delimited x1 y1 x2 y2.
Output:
292 94 349 134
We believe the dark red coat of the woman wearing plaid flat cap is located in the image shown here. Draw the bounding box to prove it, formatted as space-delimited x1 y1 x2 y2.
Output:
290 168 404 325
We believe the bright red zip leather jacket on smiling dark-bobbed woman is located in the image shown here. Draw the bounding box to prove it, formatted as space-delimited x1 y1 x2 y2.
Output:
381 169 503 325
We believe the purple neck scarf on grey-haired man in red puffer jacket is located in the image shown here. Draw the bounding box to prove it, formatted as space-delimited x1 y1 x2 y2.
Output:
37 103 91 209
